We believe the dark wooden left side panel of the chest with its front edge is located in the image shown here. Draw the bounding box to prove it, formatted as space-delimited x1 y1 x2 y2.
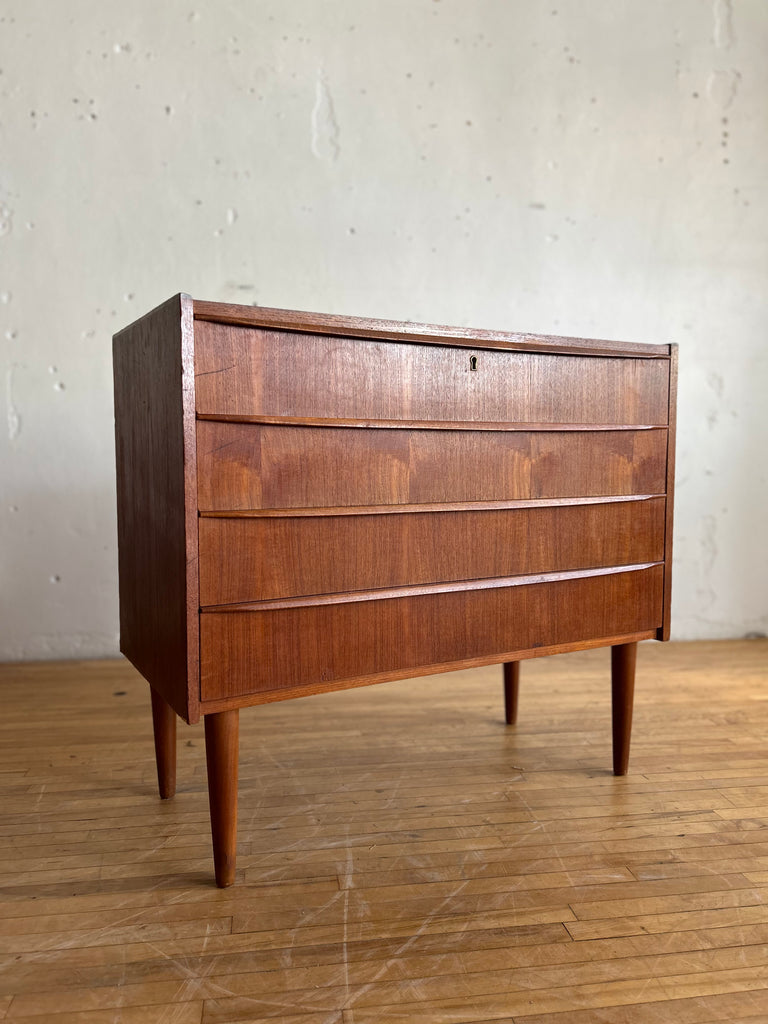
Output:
113 296 199 722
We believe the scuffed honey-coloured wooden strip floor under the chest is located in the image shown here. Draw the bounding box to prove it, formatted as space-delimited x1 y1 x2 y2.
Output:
0 640 768 1024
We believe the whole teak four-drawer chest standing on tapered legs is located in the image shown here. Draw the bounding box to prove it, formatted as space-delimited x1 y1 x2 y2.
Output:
114 295 677 886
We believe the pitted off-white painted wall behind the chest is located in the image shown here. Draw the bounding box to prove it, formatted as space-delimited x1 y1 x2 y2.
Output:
0 0 768 658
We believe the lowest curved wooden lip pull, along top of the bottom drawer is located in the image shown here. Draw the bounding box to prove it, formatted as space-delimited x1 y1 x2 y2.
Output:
200 562 664 614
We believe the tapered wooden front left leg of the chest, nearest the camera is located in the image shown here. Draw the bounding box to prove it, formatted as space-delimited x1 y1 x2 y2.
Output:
205 708 240 889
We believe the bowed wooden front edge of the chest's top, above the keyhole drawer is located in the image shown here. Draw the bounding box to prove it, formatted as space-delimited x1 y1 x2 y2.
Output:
195 299 670 358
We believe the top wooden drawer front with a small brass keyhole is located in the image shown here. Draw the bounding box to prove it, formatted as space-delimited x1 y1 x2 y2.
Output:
195 322 669 424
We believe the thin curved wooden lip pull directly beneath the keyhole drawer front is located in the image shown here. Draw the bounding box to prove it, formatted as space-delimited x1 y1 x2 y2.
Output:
196 413 670 433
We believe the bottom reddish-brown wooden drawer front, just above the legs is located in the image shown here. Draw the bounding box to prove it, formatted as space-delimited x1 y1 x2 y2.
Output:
200 566 664 700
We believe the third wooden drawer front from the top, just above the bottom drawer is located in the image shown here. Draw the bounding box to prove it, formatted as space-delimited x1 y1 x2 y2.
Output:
200 498 665 605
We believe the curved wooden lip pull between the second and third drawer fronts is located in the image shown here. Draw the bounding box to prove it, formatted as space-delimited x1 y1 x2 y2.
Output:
198 493 667 519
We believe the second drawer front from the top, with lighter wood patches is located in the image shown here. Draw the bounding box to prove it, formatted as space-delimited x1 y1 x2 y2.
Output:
198 421 667 511
